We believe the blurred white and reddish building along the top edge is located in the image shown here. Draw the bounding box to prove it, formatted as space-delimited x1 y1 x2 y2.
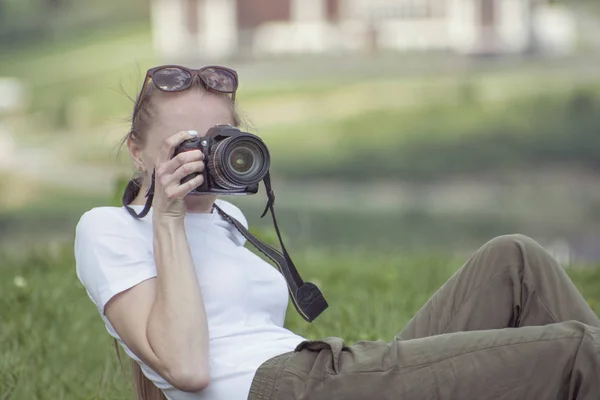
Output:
152 0 576 59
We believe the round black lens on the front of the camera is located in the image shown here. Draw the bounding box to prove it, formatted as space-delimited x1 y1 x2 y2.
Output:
209 135 270 189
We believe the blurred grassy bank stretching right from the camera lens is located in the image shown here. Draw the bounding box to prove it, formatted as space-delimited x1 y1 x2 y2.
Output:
268 86 600 181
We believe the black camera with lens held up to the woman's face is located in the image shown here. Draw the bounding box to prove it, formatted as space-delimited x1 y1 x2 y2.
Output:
173 125 271 195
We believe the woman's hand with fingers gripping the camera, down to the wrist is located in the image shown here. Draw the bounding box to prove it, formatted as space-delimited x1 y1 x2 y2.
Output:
153 131 204 219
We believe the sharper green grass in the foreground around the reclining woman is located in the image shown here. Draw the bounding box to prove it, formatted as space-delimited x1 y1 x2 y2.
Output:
0 242 600 400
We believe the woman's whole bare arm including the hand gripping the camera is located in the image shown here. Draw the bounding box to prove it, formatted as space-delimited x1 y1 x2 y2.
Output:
105 132 209 392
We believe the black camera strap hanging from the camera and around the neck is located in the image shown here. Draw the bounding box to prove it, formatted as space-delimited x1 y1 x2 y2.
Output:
123 173 328 322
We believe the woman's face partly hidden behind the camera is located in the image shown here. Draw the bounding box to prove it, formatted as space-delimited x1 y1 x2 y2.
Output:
140 88 235 209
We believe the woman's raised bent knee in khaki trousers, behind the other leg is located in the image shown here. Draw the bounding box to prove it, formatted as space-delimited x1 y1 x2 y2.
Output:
399 235 600 339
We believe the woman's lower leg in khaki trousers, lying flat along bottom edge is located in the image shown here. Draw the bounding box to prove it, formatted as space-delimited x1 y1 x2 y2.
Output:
272 321 600 400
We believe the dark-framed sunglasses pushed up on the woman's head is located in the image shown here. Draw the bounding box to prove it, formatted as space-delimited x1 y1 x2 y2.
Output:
133 65 238 119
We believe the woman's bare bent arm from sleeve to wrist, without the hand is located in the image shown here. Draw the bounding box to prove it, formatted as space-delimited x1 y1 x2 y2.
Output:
105 220 209 391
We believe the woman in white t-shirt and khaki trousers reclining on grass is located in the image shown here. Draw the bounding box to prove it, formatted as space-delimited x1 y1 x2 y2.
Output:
75 67 600 400
